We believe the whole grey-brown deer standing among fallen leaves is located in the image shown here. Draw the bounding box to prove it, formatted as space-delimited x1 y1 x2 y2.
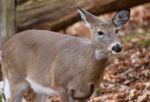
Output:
1 8 130 102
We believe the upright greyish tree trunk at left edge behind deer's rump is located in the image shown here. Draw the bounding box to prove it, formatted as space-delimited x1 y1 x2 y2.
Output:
0 0 15 50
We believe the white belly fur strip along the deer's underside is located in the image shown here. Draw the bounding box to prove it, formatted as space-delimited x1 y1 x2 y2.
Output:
26 77 58 96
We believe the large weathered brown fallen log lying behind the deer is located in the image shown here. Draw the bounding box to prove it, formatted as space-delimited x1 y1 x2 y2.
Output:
17 0 150 31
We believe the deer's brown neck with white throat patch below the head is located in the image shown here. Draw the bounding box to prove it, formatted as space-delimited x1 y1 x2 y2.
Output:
84 43 108 83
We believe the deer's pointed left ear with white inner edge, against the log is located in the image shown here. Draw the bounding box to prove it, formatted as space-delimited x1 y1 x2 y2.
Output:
78 8 94 28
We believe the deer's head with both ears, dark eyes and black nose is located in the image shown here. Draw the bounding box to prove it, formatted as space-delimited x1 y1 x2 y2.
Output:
79 8 130 54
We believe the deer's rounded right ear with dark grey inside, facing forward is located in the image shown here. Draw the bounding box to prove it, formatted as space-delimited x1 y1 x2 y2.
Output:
112 9 130 27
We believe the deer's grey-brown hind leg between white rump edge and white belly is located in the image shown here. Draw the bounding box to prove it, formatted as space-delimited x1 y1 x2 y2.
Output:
10 81 29 102
